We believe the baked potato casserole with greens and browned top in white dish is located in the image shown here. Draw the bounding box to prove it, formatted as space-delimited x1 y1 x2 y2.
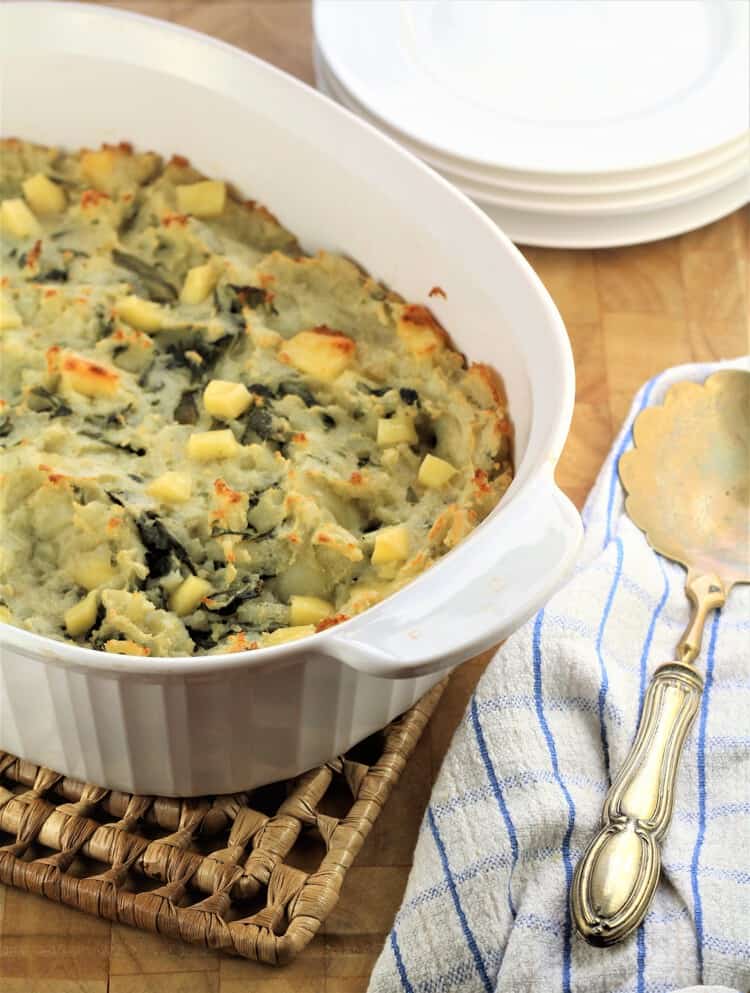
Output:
0 140 512 656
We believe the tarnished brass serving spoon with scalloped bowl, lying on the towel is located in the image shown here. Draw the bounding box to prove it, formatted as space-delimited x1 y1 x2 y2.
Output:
570 370 750 945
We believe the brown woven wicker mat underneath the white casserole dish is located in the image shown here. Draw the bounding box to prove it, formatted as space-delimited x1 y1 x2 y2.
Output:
0 683 444 965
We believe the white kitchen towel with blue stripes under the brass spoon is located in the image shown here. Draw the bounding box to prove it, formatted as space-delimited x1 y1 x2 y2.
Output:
369 360 750 993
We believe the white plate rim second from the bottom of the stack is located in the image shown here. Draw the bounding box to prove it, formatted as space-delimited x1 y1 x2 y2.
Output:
315 52 750 214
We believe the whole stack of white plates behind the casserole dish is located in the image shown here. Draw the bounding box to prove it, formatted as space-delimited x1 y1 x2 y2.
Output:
314 0 750 248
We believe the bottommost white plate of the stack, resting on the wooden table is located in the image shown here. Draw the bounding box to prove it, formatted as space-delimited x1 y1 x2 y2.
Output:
475 175 750 248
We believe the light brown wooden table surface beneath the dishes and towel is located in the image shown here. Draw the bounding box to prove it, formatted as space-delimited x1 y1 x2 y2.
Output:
0 0 750 993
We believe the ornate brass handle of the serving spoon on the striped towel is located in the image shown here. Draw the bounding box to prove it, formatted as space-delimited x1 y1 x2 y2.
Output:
570 662 703 945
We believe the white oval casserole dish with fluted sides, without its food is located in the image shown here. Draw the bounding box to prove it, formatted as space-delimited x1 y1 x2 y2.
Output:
0 2 581 796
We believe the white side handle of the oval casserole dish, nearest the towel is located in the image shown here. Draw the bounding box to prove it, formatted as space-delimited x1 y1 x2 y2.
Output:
320 468 583 679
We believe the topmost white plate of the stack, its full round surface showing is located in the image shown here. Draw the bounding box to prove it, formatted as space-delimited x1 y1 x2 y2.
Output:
314 0 750 174
